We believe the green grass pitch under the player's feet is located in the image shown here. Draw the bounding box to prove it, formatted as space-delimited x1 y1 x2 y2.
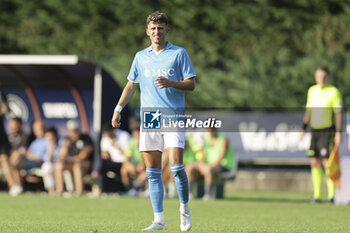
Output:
0 191 350 233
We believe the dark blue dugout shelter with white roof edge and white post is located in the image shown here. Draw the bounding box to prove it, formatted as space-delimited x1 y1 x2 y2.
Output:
0 55 130 139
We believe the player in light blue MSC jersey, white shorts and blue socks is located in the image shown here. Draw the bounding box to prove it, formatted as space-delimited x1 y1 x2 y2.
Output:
112 12 196 231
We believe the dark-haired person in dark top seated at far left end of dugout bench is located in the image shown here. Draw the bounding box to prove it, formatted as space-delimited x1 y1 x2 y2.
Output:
8 117 28 189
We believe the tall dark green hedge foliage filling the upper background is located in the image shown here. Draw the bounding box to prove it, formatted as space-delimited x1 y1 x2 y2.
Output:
0 0 350 109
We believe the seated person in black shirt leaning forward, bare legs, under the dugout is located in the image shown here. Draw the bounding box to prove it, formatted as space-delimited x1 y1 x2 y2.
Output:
55 120 93 195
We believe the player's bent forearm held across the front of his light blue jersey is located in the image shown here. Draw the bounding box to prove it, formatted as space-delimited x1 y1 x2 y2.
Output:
154 76 196 91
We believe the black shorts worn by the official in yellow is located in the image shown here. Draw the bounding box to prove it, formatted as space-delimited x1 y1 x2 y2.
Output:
307 128 334 158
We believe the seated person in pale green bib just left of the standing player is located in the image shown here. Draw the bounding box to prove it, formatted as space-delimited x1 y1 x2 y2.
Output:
120 125 147 196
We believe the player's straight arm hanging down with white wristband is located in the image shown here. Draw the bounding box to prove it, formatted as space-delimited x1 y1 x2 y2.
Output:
112 81 137 128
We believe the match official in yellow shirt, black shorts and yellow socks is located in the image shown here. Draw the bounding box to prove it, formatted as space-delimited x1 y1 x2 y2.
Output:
301 67 342 203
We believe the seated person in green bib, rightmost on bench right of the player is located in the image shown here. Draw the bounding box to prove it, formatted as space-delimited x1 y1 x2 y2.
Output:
190 128 234 200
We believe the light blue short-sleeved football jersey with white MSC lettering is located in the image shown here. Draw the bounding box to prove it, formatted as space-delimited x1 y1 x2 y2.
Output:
128 41 196 108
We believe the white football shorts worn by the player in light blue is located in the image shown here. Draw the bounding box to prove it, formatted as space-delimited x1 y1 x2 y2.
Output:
139 129 185 152
